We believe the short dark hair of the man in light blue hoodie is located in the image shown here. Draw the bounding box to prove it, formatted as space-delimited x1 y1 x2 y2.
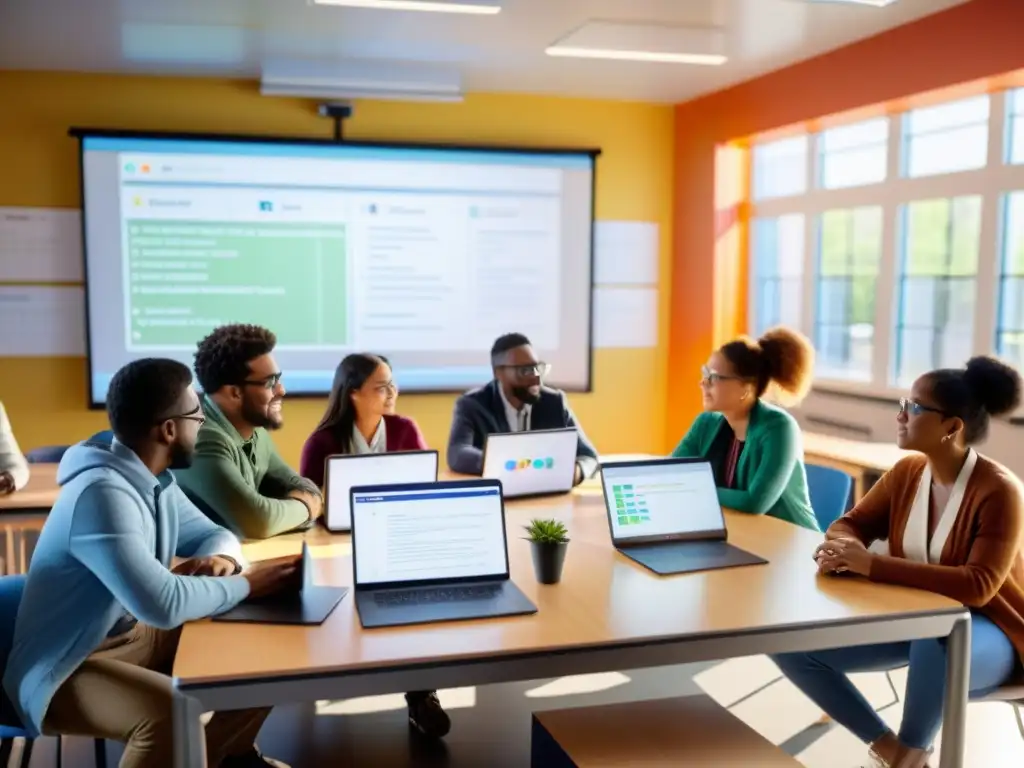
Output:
106 357 191 445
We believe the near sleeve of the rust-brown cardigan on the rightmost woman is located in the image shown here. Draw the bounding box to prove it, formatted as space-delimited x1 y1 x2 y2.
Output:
869 478 1024 608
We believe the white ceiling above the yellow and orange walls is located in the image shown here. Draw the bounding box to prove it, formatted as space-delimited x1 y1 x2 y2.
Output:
0 0 967 102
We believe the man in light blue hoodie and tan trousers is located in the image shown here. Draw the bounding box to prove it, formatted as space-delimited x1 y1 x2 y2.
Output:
3 358 298 768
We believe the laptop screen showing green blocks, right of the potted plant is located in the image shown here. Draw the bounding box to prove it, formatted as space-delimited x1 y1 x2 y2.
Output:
601 459 725 541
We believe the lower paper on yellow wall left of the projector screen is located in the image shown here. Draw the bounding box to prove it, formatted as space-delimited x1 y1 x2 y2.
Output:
0 286 85 357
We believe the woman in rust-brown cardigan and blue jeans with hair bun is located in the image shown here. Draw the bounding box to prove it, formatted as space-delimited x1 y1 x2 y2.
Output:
774 357 1024 768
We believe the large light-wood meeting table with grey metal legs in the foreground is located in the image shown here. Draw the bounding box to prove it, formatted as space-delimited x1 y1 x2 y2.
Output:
174 487 970 768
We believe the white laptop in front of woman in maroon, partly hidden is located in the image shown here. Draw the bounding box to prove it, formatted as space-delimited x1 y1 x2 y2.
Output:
324 451 438 534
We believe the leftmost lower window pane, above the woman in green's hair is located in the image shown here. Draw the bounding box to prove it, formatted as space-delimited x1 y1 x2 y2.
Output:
751 214 804 335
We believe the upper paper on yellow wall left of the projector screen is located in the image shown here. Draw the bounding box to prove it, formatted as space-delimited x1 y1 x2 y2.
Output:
0 208 82 283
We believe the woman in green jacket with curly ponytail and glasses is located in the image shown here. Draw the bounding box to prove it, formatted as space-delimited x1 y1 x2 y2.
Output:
672 328 819 530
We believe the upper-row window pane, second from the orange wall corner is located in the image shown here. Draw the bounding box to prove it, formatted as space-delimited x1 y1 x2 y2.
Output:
818 118 889 189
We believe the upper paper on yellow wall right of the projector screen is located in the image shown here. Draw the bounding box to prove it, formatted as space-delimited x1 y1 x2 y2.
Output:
594 221 658 286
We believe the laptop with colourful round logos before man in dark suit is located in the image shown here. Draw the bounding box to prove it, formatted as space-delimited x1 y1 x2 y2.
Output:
483 427 580 499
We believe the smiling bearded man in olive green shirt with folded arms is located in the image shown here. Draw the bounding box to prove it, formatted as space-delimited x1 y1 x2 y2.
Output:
177 325 324 539
